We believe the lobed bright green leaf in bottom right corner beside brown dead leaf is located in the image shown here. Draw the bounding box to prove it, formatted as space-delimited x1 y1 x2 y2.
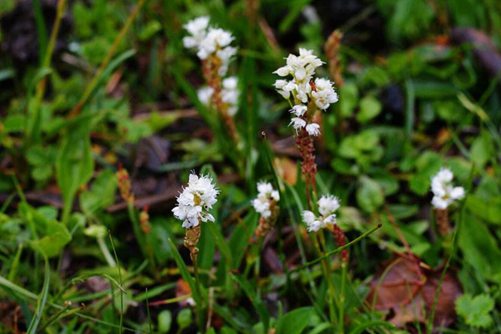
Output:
456 294 494 328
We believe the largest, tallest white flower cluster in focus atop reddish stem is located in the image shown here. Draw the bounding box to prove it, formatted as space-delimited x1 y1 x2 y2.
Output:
273 49 338 136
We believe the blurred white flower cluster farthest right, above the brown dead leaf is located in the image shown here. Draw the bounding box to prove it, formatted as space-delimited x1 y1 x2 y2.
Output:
431 168 464 210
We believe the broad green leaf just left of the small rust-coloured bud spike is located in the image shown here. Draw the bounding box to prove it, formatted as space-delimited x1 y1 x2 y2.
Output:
80 170 117 216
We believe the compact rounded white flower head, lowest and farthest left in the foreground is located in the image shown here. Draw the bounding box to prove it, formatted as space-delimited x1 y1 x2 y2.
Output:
172 174 219 228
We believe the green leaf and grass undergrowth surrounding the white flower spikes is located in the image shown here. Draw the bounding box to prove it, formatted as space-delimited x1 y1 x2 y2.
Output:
0 0 501 333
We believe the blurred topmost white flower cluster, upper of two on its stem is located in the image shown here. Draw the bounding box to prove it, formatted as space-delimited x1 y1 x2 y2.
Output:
183 16 237 76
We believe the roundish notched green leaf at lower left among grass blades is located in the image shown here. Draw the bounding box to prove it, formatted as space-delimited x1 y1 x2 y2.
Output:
30 220 71 258
